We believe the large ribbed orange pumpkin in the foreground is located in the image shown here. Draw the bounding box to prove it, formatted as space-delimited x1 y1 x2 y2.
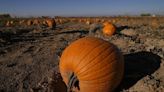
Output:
59 37 124 92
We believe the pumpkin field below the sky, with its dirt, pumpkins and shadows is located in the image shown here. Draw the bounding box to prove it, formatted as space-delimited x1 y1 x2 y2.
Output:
0 16 164 92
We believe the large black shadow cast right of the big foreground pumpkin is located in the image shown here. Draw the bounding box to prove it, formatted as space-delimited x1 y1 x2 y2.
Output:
116 51 161 92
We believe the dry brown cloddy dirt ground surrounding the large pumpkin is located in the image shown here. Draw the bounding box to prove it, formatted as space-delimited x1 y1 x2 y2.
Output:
0 18 164 92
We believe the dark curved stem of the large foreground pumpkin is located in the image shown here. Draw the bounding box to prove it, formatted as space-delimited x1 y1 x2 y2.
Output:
67 73 80 92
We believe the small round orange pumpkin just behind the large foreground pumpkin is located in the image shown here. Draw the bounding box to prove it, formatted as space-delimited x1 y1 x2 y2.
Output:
103 22 116 36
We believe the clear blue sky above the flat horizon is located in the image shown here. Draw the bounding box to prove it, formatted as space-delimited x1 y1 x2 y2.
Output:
0 0 164 16
